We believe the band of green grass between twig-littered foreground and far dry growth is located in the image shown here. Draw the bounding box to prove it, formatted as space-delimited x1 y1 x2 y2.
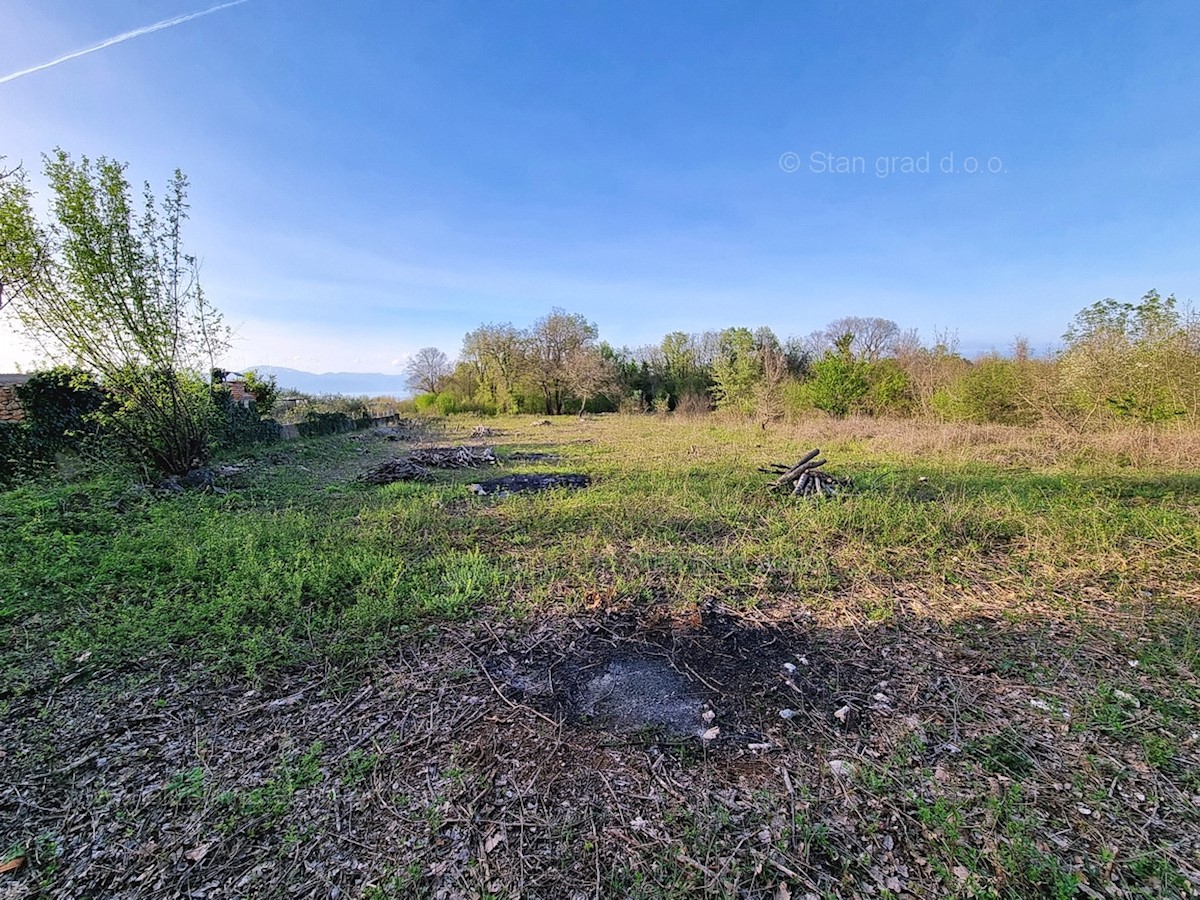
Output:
0 419 1200 686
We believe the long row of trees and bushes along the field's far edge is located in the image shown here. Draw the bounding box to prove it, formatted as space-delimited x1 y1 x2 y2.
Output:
408 290 1200 427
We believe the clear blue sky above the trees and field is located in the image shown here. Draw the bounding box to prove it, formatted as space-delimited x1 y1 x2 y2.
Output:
0 0 1200 372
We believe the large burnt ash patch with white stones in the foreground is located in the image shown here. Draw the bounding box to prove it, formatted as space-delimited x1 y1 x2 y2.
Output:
491 608 889 745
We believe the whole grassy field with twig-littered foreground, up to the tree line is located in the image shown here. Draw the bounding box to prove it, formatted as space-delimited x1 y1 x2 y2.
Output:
0 416 1200 900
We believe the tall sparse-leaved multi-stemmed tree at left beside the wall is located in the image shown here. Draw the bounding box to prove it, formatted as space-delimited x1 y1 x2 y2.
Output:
0 150 228 473
